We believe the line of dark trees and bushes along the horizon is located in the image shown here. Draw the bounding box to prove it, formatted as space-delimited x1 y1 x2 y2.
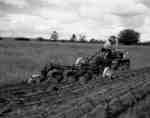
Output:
0 29 150 45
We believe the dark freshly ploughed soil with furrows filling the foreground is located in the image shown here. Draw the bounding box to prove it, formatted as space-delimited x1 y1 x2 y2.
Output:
0 67 150 118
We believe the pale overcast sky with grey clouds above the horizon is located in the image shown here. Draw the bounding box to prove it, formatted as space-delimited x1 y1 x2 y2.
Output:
0 0 150 41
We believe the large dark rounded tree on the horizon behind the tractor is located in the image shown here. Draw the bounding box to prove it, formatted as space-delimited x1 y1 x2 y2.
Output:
118 29 140 45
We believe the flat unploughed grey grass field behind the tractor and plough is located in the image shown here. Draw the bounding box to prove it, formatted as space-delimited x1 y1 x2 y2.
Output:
0 40 150 83
